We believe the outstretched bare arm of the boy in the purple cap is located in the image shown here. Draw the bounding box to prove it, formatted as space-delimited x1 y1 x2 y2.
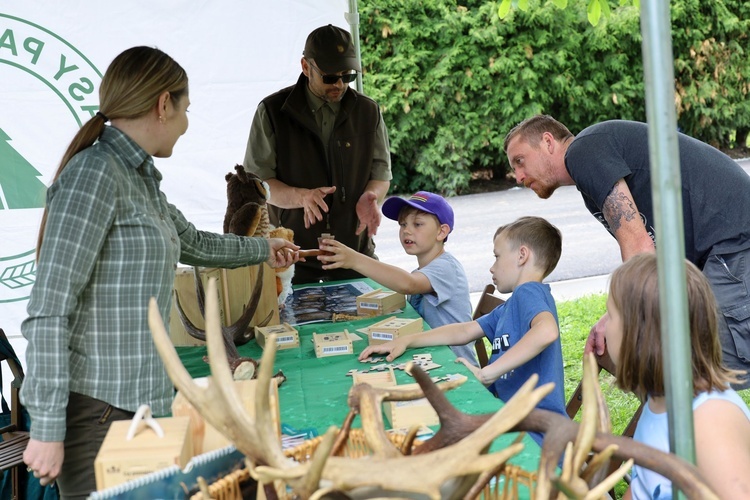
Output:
318 239 433 295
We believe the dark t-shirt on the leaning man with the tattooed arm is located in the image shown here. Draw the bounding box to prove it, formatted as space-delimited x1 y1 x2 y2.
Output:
565 120 750 268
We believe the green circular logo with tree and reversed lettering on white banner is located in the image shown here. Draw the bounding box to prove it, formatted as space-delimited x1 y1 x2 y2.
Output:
0 13 102 303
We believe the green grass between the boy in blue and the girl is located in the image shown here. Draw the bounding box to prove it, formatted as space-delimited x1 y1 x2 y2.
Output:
557 294 750 497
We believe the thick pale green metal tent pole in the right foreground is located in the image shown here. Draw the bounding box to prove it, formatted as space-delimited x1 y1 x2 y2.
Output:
641 0 695 498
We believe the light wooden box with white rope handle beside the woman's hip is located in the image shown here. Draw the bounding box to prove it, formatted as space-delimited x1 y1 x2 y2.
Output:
94 417 194 490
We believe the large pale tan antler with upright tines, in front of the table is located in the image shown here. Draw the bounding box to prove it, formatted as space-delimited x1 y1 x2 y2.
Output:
149 280 551 498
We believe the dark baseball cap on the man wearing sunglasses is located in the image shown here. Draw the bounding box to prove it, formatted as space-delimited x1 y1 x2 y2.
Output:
302 24 362 74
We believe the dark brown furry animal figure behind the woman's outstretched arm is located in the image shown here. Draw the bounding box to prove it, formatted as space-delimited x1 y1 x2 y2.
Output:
224 165 270 238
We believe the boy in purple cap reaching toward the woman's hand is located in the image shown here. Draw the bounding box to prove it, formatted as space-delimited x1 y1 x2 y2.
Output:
318 191 479 367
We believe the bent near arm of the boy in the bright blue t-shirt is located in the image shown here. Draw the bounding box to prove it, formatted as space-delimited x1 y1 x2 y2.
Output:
457 311 560 386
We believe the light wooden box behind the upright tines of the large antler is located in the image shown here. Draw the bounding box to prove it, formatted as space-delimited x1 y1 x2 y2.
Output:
172 378 281 455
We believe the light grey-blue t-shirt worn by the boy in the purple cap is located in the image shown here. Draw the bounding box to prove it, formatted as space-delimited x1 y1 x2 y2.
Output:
409 252 471 328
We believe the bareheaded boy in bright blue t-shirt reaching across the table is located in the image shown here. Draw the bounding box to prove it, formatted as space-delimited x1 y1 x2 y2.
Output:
359 217 566 444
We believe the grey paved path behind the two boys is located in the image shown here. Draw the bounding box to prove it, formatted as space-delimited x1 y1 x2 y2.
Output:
375 159 750 298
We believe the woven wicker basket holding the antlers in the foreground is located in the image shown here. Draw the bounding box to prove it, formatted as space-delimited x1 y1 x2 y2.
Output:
190 429 537 500
